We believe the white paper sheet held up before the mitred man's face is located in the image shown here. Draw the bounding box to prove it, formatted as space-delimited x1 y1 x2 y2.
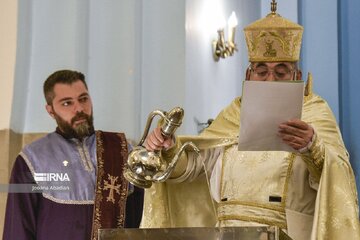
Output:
238 81 304 152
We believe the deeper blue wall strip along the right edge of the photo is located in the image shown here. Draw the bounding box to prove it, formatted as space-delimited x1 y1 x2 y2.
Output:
338 0 360 192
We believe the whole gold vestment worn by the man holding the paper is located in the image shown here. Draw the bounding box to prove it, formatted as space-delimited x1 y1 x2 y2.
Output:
142 82 360 240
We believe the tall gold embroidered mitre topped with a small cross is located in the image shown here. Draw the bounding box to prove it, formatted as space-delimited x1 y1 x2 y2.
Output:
244 0 304 62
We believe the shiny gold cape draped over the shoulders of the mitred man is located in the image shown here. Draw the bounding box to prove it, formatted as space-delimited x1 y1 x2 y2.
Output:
142 92 360 240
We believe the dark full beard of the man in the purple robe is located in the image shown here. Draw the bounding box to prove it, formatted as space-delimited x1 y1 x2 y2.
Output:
54 112 94 140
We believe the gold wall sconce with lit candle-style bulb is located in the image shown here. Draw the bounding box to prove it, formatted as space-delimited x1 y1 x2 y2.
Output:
213 12 238 61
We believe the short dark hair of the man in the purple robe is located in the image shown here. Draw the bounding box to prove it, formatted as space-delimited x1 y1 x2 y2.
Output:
43 69 88 105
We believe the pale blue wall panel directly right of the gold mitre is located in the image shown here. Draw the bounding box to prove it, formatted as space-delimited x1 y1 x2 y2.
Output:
298 0 340 121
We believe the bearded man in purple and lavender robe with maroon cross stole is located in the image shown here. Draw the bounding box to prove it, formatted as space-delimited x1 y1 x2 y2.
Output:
3 70 143 240
